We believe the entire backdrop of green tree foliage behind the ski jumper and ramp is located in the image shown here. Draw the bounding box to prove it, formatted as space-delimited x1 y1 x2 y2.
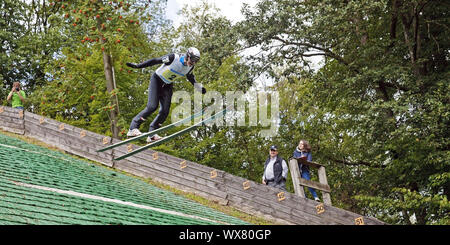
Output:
5 0 450 224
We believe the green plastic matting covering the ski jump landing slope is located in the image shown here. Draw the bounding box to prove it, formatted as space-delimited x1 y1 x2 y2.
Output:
0 133 248 225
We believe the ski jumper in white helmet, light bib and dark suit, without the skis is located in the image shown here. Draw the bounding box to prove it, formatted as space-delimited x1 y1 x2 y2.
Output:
126 47 206 142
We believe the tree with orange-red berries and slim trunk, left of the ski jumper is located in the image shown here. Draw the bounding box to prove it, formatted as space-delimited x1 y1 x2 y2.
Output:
27 0 171 138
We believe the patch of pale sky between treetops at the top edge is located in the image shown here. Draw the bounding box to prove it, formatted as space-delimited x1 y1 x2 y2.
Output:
166 0 259 27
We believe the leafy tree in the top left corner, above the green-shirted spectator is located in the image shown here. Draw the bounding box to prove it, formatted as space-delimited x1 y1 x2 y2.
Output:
0 0 70 101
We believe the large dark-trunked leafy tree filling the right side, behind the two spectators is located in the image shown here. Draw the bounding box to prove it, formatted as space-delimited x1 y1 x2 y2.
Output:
236 0 450 224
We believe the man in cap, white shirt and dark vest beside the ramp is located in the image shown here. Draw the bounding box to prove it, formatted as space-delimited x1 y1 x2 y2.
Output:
262 145 289 190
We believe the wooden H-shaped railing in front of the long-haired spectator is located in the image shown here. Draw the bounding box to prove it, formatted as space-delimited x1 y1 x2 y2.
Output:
289 158 331 206
